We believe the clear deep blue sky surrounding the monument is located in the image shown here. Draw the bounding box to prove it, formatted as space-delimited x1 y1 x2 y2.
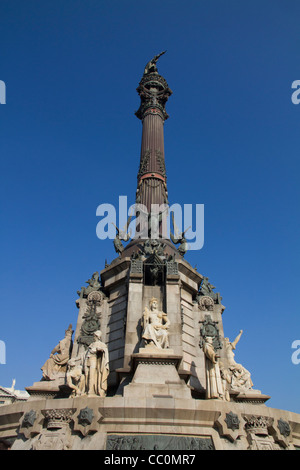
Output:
0 0 300 412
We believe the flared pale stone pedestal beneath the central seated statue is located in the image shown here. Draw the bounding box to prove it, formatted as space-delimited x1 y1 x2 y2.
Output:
123 347 191 398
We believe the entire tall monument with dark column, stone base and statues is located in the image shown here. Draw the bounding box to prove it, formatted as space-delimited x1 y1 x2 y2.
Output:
0 52 300 451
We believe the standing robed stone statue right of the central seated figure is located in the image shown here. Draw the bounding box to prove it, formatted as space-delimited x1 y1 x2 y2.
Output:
202 336 225 400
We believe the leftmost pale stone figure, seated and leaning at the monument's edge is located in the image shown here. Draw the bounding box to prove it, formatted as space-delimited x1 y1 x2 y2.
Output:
41 325 73 380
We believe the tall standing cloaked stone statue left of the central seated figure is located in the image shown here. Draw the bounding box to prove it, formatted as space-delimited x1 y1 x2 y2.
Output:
83 330 109 397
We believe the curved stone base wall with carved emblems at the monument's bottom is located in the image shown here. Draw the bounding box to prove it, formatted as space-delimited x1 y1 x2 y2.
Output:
0 392 300 453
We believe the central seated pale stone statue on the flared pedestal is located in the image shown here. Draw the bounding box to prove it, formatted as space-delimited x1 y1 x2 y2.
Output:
142 297 170 349
